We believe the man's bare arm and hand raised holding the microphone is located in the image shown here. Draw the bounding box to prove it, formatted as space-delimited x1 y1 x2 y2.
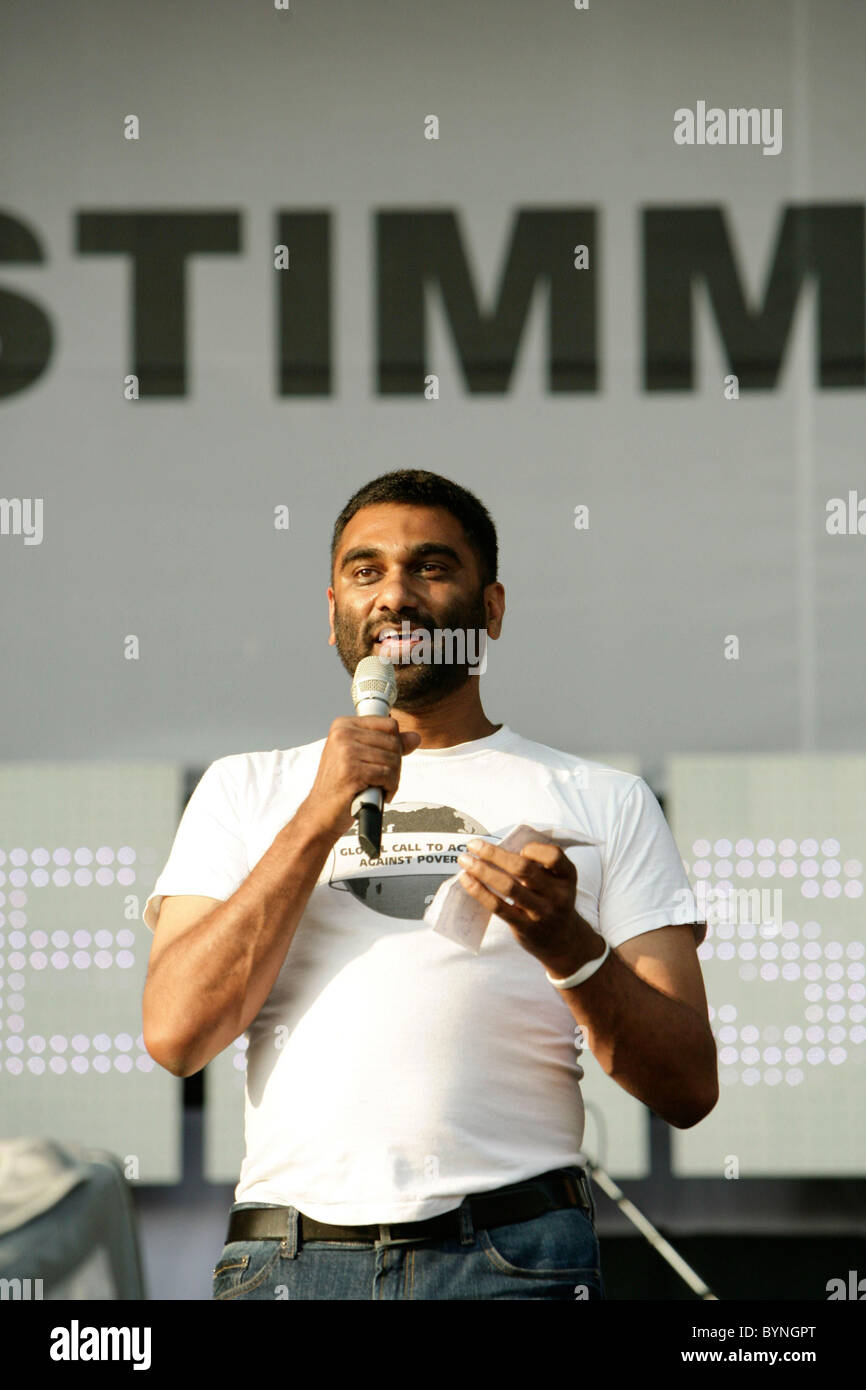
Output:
142 716 420 1076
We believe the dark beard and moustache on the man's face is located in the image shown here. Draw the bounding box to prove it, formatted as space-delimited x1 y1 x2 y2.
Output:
334 588 487 710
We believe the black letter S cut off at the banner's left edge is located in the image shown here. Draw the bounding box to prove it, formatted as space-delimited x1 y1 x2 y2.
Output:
0 213 54 398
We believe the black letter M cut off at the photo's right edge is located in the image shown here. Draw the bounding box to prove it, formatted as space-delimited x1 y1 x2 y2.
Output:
644 203 866 391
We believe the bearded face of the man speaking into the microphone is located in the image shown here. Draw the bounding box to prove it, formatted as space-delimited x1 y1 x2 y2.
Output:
328 502 505 709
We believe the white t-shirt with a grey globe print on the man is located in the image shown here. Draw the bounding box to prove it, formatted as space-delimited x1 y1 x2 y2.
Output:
145 724 706 1225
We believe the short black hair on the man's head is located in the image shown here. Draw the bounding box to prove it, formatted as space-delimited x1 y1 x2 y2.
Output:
331 468 499 588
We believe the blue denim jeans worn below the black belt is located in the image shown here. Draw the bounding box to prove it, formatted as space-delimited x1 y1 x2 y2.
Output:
213 1166 606 1301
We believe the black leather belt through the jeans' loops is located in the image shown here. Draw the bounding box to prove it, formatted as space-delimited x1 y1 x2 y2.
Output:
225 1169 592 1245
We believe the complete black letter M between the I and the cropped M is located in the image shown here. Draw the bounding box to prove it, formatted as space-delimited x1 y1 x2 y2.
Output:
377 207 599 398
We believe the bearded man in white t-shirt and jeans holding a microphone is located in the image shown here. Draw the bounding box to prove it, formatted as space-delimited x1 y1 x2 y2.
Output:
143 470 719 1300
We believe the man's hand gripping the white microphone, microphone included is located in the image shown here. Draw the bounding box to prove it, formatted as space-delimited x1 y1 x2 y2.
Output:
300 656 421 859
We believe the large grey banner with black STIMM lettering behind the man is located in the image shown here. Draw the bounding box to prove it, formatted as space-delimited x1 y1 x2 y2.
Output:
0 0 866 765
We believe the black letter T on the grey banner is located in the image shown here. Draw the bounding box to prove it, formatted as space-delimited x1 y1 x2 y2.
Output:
78 211 240 398
